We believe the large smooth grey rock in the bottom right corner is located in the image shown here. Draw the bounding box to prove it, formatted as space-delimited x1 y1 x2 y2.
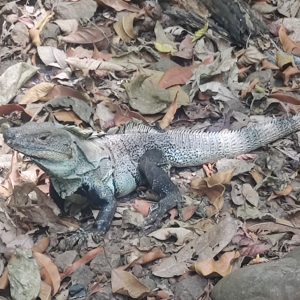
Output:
212 247 300 300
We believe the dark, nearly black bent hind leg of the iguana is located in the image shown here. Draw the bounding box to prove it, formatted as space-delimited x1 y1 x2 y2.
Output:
139 149 181 231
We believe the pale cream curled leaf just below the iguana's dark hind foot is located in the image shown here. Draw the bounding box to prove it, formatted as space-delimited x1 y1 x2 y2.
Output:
149 227 194 245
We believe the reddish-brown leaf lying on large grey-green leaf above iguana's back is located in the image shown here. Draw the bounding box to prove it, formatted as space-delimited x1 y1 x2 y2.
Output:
159 64 198 89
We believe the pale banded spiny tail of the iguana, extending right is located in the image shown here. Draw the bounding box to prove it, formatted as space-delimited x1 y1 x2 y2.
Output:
165 115 300 167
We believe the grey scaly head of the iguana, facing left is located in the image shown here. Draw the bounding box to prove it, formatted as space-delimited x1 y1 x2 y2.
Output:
3 123 79 177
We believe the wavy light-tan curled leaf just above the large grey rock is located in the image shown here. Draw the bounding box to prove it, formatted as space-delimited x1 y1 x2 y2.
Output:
192 251 240 277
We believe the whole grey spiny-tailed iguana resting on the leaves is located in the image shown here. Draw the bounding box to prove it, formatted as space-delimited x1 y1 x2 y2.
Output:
4 116 300 233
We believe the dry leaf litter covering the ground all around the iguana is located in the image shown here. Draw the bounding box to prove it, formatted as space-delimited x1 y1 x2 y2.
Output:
0 0 300 299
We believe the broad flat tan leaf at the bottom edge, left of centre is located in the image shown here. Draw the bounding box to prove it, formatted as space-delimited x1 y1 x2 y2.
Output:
111 269 150 299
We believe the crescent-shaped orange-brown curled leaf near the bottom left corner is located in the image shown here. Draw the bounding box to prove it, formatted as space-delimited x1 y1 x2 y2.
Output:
33 252 60 296
